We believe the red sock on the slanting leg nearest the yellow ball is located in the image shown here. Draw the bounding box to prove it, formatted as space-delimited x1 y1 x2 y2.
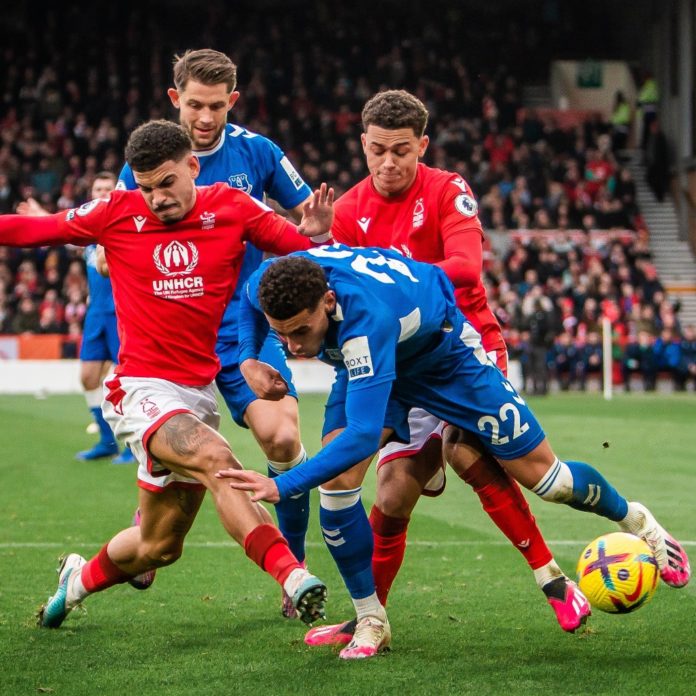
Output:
462 455 553 570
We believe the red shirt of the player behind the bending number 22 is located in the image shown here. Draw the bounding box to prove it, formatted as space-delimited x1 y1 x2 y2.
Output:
332 164 505 352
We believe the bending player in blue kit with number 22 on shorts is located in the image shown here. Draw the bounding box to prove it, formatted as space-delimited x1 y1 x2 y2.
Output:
218 245 691 659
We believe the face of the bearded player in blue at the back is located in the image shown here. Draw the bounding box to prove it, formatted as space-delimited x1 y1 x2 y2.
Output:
167 80 239 150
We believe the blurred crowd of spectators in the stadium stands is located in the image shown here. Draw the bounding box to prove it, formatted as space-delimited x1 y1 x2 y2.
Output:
0 2 696 386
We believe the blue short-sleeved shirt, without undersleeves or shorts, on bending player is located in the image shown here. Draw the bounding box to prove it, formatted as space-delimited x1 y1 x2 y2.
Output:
240 244 456 389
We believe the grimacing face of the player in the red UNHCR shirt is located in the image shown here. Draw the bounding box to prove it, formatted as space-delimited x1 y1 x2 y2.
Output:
133 155 200 224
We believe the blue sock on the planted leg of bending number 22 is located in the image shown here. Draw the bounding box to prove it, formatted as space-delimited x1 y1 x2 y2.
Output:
319 489 375 599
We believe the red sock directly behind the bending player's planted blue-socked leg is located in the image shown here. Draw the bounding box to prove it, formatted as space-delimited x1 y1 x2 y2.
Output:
370 505 410 605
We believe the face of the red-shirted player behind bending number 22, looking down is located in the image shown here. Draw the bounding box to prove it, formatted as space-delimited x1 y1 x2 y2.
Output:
361 125 428 196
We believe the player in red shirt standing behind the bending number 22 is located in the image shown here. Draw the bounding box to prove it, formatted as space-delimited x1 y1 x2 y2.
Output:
305 90 589 656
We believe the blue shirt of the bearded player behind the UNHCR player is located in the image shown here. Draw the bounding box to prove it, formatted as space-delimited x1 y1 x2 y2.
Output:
118 123 312 352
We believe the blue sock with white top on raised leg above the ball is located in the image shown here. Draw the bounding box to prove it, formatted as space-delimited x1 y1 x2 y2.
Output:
532 459 628 522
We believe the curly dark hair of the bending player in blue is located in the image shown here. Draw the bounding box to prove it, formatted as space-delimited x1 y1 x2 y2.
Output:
259 256 329 321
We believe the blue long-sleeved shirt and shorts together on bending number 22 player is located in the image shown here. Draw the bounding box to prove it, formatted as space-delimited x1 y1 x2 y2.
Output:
240 244 544 498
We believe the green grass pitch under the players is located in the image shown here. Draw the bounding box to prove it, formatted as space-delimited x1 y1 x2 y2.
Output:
0 394 696 696
